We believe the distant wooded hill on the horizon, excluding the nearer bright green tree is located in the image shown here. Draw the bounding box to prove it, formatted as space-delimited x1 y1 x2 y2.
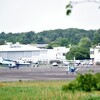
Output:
0 28 97 47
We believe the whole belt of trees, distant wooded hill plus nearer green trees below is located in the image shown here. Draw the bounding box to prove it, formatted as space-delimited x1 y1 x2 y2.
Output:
0 28 100 59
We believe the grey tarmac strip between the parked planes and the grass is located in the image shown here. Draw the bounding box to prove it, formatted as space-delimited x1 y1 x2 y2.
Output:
0 66 100 82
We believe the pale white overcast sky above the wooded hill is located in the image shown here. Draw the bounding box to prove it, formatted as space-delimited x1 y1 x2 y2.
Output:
0 0 100 33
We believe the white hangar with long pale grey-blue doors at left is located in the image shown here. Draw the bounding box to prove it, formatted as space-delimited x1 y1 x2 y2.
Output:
0 43 47 60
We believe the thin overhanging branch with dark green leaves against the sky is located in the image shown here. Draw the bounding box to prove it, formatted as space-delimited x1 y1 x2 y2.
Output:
66 0 100 15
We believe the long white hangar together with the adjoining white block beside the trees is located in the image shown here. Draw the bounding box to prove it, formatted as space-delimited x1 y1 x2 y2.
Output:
0 43 69 62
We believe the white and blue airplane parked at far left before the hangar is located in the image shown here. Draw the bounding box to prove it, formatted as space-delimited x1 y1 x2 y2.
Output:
0 57 30 69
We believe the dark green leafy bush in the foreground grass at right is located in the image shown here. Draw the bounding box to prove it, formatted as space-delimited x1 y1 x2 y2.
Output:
62 73 100 92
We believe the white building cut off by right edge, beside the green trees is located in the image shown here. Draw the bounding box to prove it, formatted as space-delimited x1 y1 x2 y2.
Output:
90 44 100 64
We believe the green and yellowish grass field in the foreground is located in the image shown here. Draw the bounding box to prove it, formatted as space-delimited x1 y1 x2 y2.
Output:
0 81 100 100
